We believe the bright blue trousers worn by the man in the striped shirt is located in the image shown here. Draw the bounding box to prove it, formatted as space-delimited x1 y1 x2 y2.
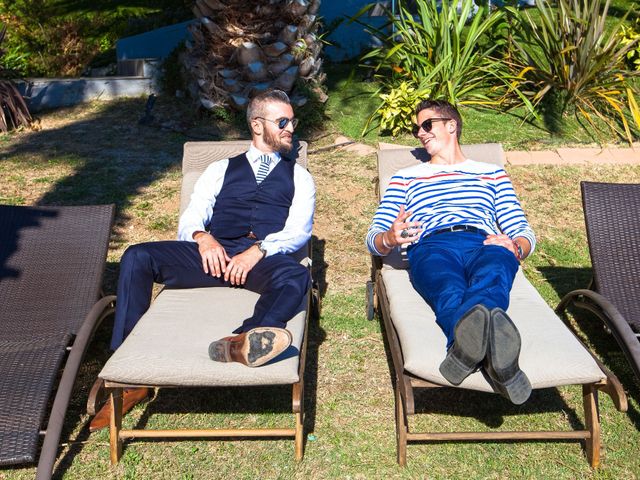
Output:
407 232 520 348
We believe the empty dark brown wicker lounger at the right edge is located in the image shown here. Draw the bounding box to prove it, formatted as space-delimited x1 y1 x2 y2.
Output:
556 182 640 382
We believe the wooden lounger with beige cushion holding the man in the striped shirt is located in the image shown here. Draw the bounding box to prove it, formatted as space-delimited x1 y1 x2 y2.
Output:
367 144 627 467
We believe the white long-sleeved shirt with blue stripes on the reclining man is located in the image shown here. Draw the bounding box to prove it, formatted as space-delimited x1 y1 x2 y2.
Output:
366 160 536 255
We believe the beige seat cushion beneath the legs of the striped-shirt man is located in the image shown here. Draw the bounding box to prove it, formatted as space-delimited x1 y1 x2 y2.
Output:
382 268 605 392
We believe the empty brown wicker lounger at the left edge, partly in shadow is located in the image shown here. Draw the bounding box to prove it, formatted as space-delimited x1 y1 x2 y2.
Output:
0 205 115 479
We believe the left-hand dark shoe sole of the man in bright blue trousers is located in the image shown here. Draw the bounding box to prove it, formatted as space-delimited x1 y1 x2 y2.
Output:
439 305 489 385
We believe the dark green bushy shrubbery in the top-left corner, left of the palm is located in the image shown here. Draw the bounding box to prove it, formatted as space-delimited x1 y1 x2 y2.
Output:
0 0 193 77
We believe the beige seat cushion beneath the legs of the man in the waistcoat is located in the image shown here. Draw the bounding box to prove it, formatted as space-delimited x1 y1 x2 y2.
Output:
99 287 307 386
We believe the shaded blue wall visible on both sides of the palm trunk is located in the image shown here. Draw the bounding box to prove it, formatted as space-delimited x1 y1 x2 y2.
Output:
116 0 384 61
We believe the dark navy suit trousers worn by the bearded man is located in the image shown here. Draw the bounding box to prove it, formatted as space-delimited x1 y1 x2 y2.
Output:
111 241 311 350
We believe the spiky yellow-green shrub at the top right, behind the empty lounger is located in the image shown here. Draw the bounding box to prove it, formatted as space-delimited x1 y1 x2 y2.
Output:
509 0 640 142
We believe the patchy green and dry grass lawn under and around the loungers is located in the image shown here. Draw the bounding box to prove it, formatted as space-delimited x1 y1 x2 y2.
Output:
0 93 640 480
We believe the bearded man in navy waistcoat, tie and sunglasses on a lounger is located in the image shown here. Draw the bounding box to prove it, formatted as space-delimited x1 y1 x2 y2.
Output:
90 90 315 431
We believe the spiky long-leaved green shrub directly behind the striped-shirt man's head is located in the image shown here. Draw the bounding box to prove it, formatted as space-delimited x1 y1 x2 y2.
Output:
362 0 531 132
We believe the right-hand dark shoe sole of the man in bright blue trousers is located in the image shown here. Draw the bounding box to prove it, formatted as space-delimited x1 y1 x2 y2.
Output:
490 310 531 405
